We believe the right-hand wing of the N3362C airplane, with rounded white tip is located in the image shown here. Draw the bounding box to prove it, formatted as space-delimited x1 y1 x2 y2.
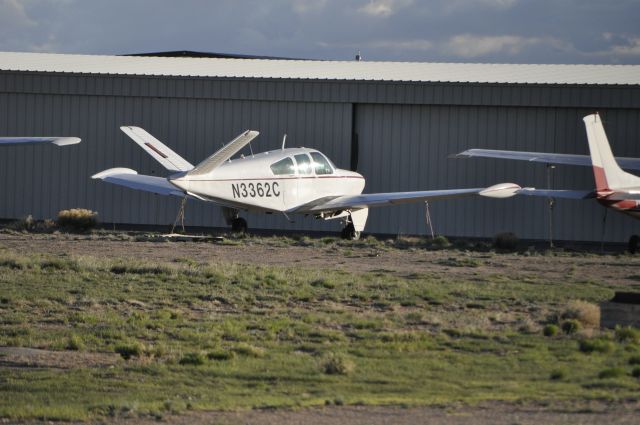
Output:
288 183 520 213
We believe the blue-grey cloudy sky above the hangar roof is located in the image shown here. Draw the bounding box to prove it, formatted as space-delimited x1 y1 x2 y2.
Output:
0 0 640 64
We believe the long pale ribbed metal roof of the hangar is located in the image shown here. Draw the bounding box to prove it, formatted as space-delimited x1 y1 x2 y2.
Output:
0 52 640 85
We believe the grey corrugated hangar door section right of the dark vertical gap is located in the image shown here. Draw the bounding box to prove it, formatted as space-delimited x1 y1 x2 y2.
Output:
356 104 640 241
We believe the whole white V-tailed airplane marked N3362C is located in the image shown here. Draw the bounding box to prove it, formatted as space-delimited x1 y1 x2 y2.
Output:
92 126 520 239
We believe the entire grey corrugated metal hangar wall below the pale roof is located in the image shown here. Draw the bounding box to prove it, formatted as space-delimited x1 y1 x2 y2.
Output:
0 72 640 241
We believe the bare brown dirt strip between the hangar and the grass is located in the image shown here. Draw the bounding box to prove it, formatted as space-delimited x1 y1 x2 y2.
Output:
0 233 640 287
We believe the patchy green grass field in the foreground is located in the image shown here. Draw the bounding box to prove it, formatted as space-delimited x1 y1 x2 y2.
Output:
0 235 640 420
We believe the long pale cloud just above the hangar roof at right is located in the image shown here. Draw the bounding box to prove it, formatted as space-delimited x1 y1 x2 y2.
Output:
443 34 569 58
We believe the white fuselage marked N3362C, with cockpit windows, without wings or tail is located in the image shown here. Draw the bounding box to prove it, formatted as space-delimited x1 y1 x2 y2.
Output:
168 148 365 212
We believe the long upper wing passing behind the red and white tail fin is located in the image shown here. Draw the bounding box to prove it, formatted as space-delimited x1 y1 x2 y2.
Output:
454 149 640 170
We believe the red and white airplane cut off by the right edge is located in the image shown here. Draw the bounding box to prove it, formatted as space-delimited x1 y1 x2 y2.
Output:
456 113 640 252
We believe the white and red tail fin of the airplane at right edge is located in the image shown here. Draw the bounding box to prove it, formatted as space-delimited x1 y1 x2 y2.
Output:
583 113 640 191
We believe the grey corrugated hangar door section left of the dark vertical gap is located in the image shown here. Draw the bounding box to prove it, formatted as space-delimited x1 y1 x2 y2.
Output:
0 94 351 230
